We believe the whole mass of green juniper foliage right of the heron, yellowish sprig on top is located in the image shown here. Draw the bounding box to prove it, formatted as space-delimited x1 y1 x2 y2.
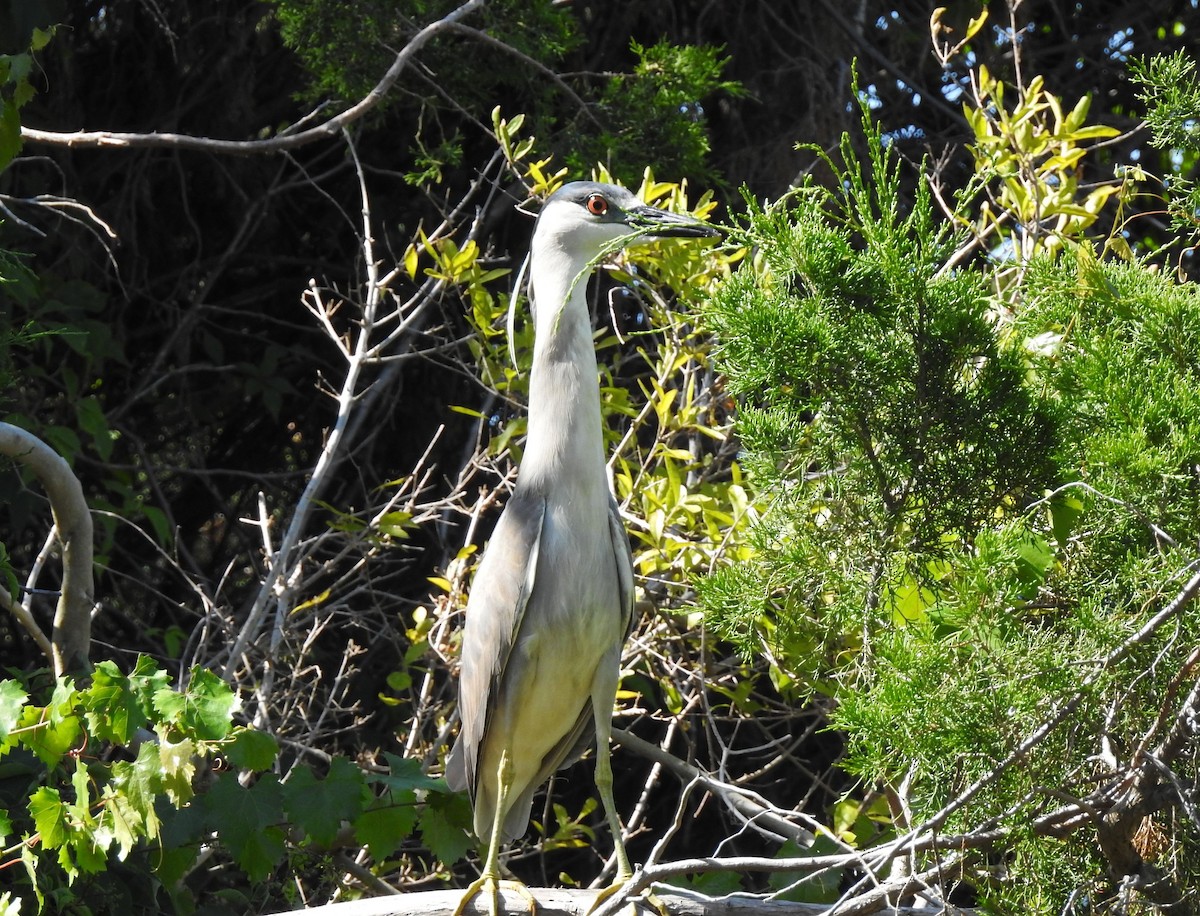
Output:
697 69 1200 912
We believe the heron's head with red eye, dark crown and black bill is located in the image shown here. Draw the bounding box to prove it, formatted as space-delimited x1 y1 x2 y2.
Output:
534 181 720 261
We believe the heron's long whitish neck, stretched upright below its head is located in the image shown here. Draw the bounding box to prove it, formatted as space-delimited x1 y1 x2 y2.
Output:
518 239 607 502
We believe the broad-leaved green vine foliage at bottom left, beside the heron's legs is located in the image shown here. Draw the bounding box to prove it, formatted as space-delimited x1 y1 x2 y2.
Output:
0 655 470 914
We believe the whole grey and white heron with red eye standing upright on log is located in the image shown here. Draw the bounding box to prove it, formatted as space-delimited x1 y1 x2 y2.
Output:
446 181 718 914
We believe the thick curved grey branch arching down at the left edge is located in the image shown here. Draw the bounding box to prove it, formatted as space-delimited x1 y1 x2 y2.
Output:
0 423 96 675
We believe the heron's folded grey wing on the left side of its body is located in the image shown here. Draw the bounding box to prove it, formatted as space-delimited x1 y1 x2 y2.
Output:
446 489 546 801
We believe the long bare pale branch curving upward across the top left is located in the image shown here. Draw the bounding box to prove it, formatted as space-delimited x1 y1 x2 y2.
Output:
20 0 487 155
